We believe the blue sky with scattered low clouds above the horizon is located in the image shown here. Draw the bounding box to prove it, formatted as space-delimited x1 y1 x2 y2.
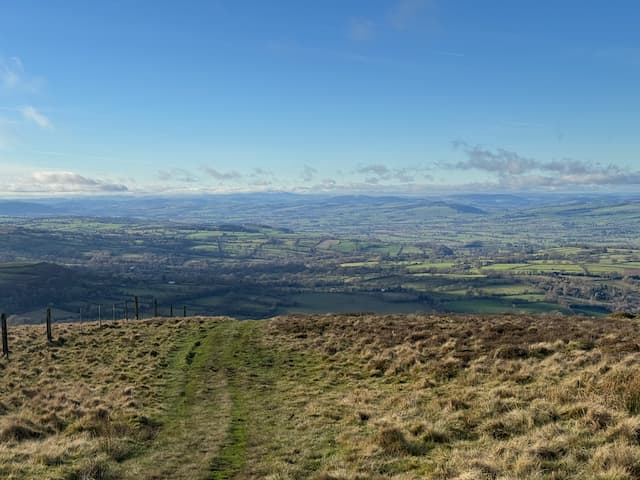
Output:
0 0 640 197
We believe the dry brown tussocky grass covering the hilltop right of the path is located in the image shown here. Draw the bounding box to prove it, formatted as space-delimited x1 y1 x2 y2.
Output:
265 315 640 479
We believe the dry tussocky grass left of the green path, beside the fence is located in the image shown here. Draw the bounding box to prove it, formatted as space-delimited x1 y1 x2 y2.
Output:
0 320 216 480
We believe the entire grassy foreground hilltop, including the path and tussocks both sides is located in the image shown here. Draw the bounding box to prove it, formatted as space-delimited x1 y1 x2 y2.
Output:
0 315 640 480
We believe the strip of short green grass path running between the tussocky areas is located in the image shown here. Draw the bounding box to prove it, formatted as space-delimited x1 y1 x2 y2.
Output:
123 320 333 480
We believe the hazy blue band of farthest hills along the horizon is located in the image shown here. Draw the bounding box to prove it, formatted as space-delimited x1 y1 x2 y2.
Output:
0 192 640 221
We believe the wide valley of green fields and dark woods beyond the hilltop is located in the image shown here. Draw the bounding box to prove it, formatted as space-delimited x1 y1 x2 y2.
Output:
6 197 640 323
